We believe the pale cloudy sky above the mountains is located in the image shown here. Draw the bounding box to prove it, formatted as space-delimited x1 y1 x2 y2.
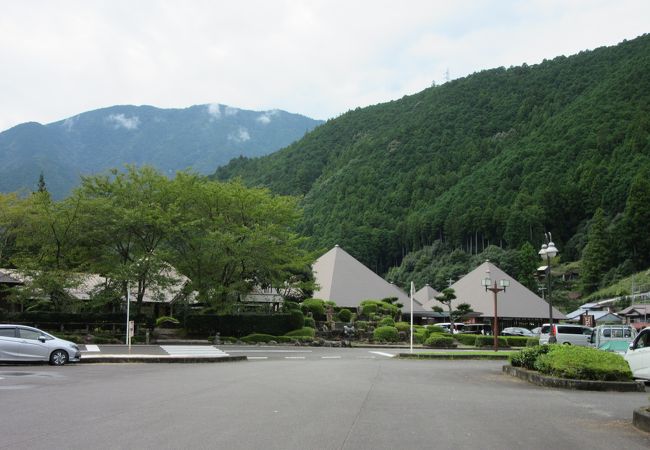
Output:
0 0 650 131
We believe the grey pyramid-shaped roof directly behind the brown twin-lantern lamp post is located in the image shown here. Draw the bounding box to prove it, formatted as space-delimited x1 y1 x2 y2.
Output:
451 261 566 320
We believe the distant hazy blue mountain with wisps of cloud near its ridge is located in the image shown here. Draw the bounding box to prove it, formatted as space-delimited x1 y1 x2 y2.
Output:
0 104 321 198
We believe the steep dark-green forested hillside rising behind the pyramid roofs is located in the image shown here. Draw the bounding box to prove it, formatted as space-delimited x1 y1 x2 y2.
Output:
215 35 650 288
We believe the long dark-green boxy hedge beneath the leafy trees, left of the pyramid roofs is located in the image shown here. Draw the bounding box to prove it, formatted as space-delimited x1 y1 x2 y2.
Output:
185 311 305 337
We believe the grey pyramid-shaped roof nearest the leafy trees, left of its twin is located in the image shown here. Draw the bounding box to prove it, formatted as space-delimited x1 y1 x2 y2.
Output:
313 245 422 312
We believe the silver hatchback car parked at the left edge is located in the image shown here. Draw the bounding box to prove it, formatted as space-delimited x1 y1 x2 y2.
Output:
0 325 81 366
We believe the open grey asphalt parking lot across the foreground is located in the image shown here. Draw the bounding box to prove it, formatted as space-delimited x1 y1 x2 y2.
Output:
0 356 650 450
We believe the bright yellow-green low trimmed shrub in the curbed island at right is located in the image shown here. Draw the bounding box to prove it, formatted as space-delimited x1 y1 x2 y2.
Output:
535 345 632 381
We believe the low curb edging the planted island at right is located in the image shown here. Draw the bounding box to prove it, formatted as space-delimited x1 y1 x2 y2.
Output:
503 365 645 392
